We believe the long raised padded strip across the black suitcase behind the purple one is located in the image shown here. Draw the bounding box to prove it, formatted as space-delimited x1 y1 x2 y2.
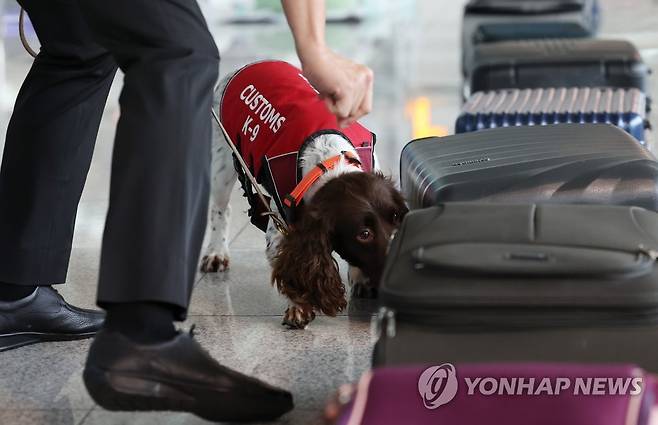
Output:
412 242 655 278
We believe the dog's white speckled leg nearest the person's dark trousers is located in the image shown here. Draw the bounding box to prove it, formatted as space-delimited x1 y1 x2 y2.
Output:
201 105 238 273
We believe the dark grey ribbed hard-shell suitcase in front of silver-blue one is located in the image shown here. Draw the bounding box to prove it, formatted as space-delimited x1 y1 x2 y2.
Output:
400 124 658 211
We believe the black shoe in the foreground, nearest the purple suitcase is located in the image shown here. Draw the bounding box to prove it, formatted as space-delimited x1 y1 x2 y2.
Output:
83 330 293 421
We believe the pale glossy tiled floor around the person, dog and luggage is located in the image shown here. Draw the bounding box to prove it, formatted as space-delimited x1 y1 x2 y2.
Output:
0 0 658 425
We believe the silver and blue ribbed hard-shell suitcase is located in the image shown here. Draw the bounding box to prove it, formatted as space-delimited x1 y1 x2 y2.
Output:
455 87 648 144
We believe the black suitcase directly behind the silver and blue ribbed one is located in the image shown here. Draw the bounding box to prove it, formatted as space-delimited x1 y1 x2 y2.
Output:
465 39 649 98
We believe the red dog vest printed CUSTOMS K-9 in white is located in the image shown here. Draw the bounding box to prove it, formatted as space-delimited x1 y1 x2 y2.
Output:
220 61 375 225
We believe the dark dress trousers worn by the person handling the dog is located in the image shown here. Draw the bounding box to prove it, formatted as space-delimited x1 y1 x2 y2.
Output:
0 0 219 316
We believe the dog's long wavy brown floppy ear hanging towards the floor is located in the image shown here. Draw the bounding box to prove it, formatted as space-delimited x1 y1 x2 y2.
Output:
272 210 347 316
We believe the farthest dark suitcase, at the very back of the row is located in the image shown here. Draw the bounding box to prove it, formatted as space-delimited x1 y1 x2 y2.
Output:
462 0 600 74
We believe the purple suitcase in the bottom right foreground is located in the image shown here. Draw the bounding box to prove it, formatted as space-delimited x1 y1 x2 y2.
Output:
337 363 655 425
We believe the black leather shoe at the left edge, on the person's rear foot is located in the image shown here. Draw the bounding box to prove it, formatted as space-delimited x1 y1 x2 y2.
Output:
0 286 105 351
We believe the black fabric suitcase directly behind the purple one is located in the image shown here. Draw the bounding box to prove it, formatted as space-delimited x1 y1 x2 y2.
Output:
374 202 658 372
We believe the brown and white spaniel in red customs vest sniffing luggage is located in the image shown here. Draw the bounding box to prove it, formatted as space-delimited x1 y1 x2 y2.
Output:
201 61 408 328
